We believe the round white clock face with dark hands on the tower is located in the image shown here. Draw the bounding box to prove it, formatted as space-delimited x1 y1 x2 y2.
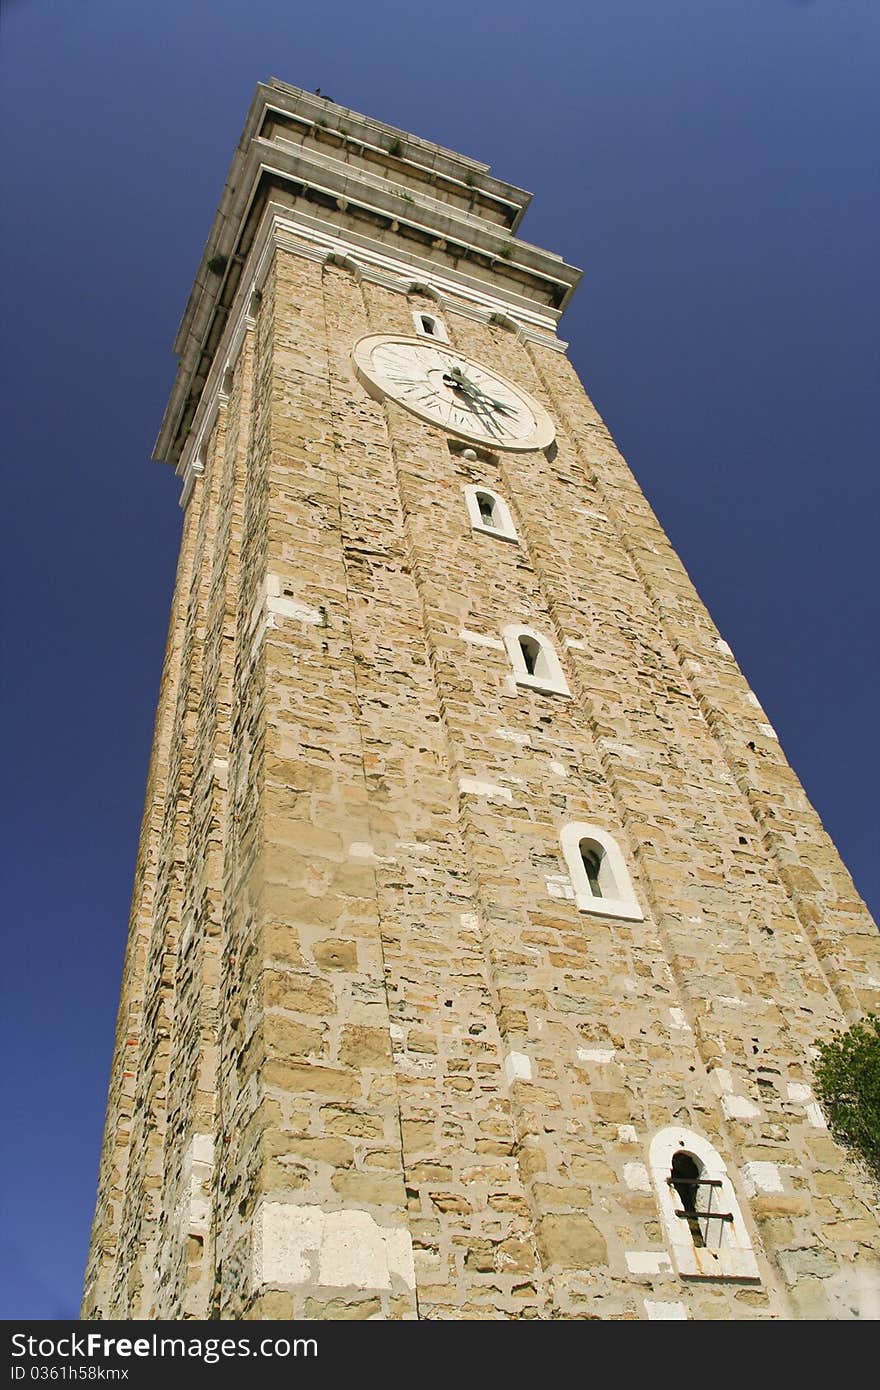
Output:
353 334 555 449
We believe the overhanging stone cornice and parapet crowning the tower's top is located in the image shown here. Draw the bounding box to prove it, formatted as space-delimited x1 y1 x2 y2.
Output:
154 78 581 464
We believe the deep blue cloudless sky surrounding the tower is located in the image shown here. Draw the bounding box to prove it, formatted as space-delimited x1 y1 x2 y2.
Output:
0 0 880 1318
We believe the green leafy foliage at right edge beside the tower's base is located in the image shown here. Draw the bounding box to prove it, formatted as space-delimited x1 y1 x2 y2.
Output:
813 1013 880 1183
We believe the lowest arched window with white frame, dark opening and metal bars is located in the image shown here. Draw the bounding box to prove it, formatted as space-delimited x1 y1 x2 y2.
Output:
648 1125 760 1283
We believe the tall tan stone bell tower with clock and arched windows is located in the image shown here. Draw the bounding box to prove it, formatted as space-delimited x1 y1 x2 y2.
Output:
83 81 880 1319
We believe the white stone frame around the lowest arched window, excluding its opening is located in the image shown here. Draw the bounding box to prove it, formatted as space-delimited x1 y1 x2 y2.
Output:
648 1125 760 1283
